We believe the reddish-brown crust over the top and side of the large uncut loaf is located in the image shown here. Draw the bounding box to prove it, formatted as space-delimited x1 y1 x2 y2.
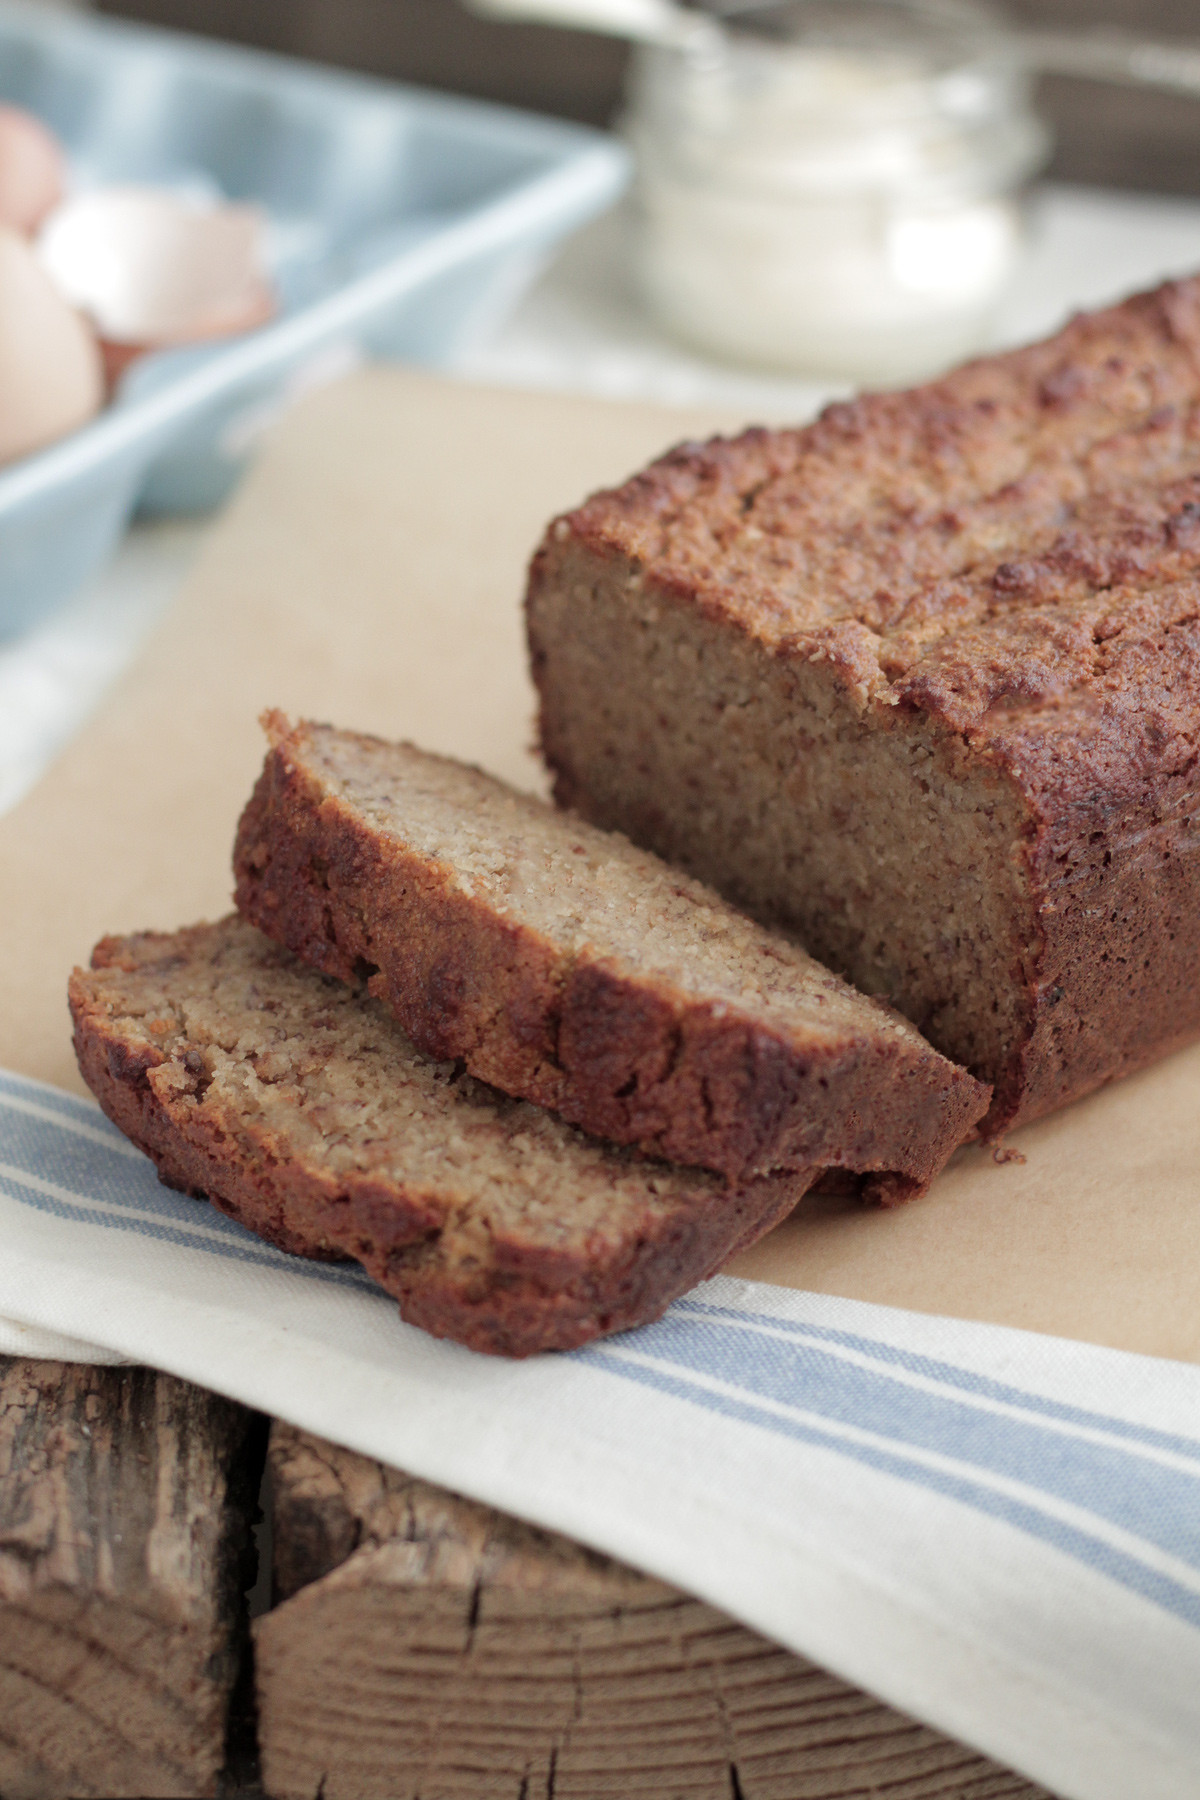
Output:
527 279 1200 1136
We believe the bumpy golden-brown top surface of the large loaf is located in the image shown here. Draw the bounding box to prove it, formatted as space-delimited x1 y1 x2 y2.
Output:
554 277 1200 687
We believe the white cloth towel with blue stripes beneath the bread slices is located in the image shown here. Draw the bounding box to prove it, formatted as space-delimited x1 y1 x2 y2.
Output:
0 1051 1200 1800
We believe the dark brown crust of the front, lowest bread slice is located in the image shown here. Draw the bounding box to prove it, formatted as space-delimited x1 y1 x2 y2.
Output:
68 922 811 1357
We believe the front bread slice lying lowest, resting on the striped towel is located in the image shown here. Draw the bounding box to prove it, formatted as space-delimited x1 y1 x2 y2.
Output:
70 916 811 1355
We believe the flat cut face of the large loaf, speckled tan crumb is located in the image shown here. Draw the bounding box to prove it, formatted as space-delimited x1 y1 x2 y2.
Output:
529 545 1036 1136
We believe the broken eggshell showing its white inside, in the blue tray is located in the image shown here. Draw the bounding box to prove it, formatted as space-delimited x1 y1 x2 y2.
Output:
38 187 273 347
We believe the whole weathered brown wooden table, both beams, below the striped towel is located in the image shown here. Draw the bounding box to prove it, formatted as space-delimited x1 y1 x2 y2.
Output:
0 1357 1045 1800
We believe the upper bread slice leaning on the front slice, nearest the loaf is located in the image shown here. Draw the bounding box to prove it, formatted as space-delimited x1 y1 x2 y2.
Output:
234 713 990 1199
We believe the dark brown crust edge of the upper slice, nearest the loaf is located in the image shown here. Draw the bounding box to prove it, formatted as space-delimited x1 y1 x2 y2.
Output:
234 715 990 1202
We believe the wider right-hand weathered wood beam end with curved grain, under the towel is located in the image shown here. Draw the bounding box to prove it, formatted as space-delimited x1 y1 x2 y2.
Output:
255 1422 1045 1800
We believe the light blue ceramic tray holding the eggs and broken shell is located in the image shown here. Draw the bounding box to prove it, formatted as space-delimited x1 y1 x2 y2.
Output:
0 4 626 634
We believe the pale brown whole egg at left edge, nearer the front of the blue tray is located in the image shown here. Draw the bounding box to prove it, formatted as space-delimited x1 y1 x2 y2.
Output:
0 227 104 463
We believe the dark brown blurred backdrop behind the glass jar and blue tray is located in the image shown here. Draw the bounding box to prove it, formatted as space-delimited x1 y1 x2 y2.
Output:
97 0 1200 194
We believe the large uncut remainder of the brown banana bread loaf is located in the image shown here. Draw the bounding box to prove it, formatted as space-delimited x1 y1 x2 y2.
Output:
527 279 1200 1134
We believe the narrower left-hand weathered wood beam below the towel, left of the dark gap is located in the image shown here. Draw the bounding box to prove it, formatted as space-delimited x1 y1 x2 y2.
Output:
0 1357 261 1800
